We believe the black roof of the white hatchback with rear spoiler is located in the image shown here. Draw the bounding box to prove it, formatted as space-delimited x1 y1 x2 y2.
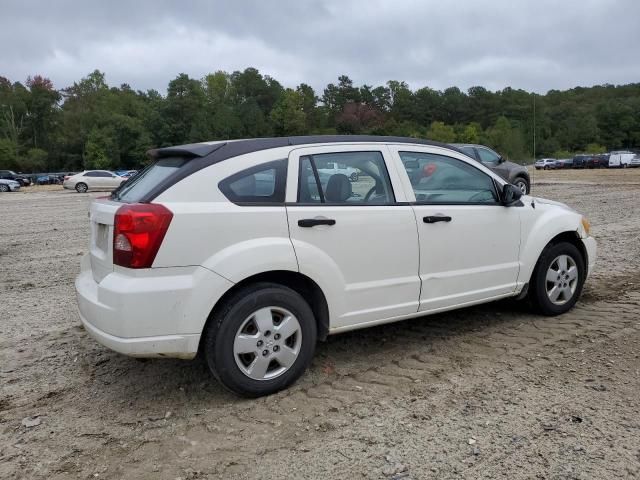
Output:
147 135 464 164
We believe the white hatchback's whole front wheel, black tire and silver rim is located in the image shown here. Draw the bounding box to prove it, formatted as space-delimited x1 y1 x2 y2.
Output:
529 242 586 316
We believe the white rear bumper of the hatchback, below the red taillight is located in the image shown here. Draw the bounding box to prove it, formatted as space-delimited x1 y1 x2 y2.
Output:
75 255 233 358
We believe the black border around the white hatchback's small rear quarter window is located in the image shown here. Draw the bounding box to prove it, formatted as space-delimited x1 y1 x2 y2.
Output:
218 158 288 207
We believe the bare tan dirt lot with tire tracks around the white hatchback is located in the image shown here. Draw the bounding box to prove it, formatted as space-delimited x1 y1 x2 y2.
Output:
0 169 640 480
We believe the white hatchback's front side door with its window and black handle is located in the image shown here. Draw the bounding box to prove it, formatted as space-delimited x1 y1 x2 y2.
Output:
389 146 520 311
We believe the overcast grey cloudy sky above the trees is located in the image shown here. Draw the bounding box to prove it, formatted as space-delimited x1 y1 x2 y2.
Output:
0 0 640 94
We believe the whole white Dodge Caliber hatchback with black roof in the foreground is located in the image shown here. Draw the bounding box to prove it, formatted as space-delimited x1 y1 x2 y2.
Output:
76 136 596 396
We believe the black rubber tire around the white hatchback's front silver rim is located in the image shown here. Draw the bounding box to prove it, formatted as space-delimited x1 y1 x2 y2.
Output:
529 242 585 316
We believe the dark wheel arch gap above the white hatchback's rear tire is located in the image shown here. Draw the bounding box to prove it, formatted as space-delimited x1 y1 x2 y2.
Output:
198 270 329 352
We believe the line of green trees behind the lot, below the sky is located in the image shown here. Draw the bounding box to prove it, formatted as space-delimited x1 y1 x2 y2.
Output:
0 68 640 172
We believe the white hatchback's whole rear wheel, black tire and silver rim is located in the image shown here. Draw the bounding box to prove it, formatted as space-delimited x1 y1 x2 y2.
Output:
203 283 317 397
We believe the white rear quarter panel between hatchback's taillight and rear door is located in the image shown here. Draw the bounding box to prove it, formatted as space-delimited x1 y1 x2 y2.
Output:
153 148 298 283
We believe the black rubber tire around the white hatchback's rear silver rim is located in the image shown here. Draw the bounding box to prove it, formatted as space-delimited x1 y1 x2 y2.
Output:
202 282 317 397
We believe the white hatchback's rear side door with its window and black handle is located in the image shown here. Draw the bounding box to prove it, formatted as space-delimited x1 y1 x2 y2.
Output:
287 144 420 329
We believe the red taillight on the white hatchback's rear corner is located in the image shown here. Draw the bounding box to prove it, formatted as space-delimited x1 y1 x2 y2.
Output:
113 203 173 268
